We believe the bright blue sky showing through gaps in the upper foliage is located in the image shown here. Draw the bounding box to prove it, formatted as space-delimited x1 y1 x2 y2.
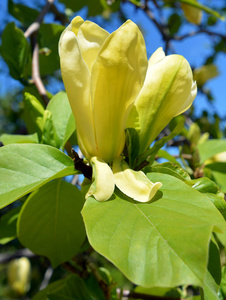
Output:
0 0 226 121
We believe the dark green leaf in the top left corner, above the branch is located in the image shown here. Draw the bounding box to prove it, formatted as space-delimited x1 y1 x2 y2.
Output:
8 0 39 27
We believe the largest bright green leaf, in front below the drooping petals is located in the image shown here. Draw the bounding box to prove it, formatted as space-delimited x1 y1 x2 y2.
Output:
82 173 225 287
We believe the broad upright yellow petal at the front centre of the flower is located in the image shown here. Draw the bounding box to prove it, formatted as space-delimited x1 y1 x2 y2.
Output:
91 20 147 162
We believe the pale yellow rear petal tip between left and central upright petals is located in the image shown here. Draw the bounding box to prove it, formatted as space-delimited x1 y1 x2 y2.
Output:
77 21 109 71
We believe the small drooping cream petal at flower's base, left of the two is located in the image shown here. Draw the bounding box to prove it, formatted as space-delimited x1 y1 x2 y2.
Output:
86 157 115 201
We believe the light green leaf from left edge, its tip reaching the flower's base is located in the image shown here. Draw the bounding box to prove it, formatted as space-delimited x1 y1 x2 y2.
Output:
0 144 76 208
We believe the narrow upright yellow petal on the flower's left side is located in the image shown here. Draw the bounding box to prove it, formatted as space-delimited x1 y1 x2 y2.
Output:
60 30 96 159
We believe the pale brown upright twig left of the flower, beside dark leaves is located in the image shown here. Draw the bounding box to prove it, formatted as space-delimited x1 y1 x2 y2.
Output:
32 35 49 105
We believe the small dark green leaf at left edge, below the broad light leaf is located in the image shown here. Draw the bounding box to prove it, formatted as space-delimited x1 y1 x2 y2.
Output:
0 207 21 245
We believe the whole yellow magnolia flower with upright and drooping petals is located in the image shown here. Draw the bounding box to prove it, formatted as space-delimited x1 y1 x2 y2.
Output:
59 17 196 202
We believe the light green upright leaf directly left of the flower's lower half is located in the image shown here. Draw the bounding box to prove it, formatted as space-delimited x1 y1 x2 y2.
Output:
46 92 75 149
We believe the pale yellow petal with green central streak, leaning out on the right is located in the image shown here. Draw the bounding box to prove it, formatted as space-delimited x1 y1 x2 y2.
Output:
128 51 197 152
